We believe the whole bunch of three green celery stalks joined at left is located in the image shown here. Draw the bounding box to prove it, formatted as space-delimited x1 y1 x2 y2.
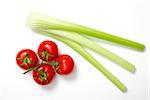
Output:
27 13 145 92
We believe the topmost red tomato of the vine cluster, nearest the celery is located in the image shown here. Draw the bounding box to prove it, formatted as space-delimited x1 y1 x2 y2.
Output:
38 40 58 61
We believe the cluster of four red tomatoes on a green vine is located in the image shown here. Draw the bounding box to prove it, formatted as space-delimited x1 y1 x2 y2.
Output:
16 40 74 85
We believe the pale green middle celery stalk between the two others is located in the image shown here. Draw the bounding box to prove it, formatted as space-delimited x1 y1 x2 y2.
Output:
44 30 135 72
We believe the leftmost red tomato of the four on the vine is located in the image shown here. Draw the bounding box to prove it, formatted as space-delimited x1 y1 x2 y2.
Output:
16 49 38 70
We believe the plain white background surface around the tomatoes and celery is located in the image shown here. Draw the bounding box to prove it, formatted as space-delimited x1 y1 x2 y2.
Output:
0 0 150 100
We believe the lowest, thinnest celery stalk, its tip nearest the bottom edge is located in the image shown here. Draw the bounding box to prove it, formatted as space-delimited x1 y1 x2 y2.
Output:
40 32 127 92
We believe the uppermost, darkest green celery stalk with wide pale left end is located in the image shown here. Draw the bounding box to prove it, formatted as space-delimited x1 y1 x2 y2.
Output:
27 13 145 51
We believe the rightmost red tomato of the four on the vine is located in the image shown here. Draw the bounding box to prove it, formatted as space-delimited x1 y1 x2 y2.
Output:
54 55 74 74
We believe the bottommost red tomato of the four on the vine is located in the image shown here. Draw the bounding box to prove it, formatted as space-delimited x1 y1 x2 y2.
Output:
32 64 55 85
